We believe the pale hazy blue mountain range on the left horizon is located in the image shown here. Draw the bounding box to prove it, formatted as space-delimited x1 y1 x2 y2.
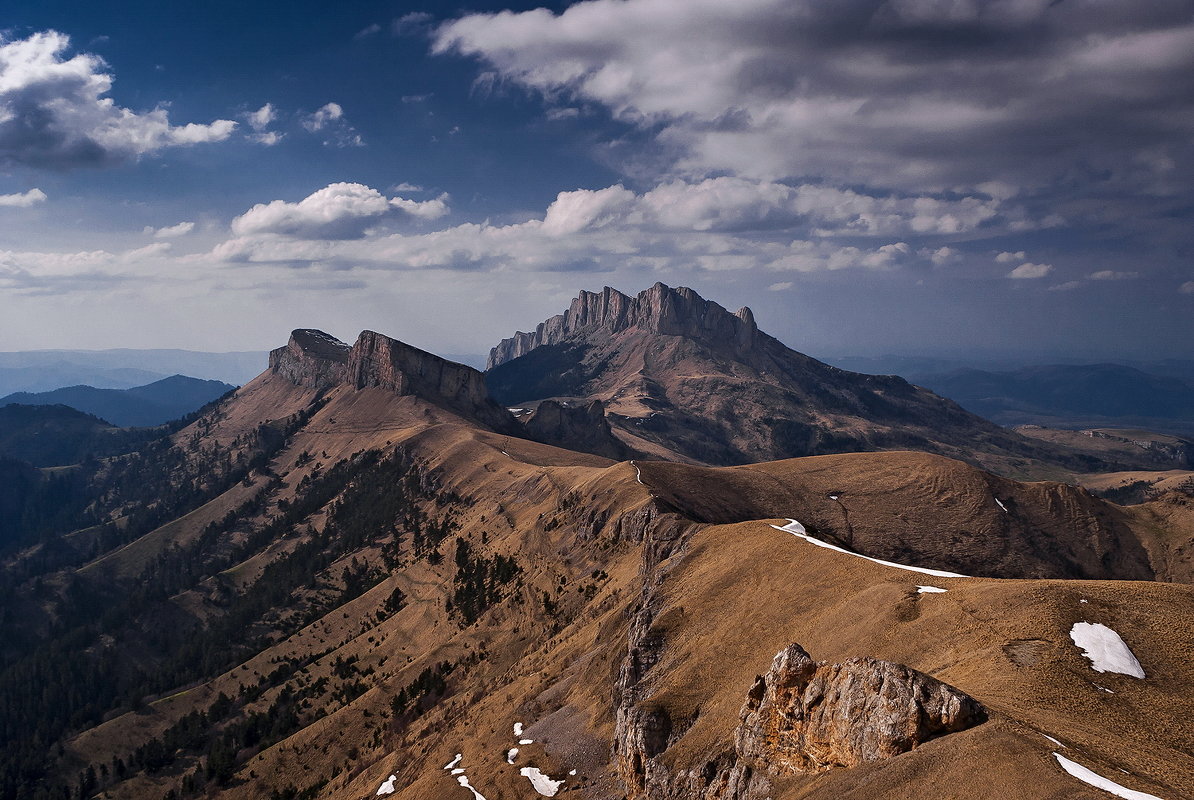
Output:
0 349 266 396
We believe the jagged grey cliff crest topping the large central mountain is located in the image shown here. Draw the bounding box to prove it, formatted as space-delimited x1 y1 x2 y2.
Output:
486 282 758 369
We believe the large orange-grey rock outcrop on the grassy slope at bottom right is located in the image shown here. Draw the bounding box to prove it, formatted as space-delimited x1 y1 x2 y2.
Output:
734 644 986 775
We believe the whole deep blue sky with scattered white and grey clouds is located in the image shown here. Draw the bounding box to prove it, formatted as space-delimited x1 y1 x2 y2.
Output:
0 0 1194 359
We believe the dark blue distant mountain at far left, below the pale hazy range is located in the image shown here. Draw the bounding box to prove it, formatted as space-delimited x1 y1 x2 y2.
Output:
0 375 235 427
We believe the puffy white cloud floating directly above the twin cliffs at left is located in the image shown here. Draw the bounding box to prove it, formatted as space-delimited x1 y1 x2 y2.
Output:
232 183 448 240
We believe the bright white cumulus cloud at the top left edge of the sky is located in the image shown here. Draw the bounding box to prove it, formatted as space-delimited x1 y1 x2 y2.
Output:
0 31 236 170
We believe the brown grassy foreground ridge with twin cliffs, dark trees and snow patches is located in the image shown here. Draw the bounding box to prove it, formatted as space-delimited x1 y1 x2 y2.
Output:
0 317 1194 800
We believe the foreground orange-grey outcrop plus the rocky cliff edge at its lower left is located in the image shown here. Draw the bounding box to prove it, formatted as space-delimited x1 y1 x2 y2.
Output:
616 644 987 800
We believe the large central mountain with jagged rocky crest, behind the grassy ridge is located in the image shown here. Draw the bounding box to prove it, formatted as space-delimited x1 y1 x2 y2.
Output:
486 283 1103 472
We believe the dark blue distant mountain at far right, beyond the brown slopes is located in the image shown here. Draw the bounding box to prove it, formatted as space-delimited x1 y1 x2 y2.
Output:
902 364 1194 433
